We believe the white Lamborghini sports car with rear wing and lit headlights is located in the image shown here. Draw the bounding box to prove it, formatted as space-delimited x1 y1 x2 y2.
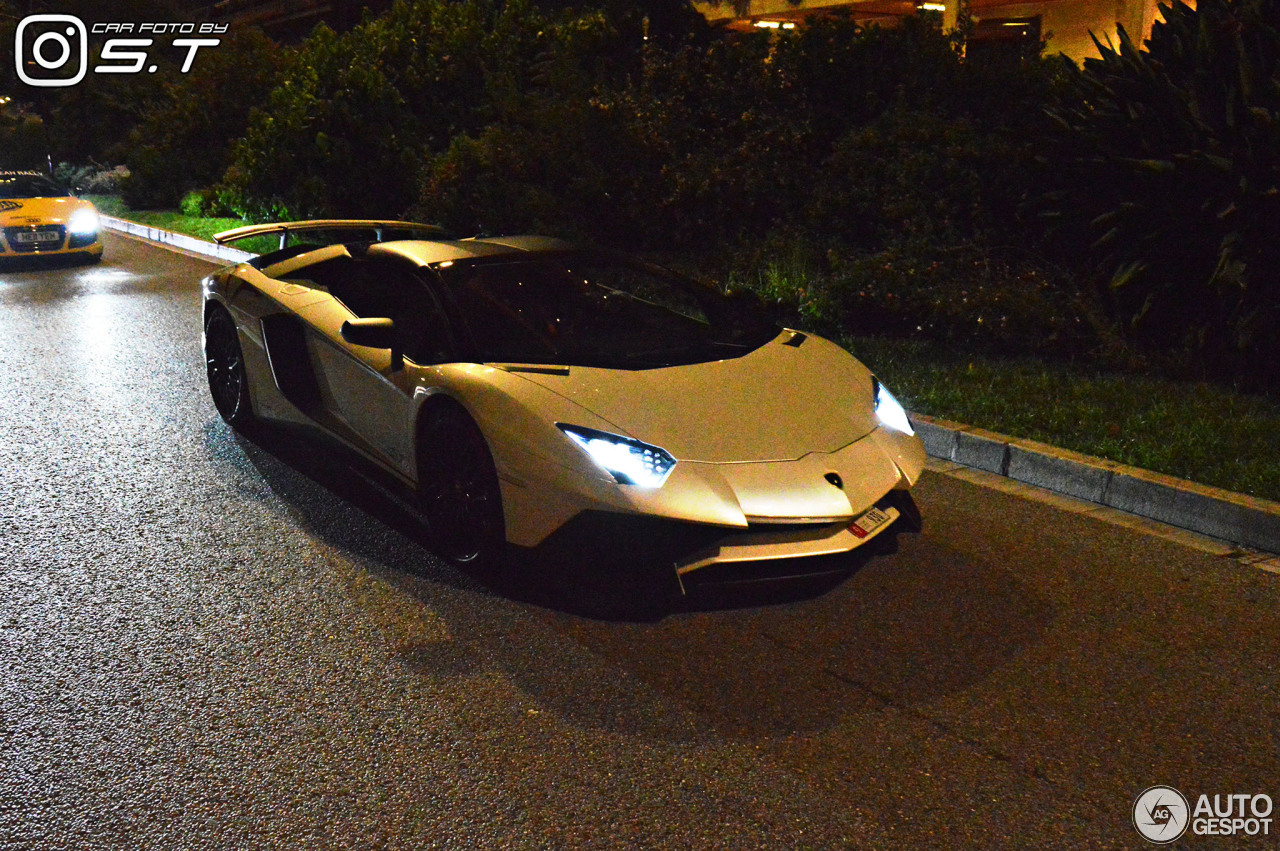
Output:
204 221 924 590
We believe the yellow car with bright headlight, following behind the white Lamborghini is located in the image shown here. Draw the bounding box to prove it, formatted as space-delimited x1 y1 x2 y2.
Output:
0 171 102 261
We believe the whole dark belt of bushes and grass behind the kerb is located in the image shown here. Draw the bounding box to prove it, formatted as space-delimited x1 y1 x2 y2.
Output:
15 0 1280 499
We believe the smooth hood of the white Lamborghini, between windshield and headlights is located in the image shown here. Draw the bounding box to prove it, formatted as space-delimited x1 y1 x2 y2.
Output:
507 331 877 463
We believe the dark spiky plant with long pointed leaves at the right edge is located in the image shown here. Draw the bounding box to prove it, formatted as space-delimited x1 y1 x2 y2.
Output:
1046 0 1280 381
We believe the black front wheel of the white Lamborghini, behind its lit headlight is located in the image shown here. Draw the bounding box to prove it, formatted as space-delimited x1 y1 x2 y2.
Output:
417 402 507 577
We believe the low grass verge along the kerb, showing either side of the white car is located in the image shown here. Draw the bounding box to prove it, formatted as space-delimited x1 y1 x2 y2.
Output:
91 196 1280 502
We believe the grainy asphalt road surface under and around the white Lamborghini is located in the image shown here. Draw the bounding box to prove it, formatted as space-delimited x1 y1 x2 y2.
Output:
0 229 1280 850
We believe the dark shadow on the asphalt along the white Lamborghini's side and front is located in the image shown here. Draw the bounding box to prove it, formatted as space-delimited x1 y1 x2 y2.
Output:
204 417 1053 741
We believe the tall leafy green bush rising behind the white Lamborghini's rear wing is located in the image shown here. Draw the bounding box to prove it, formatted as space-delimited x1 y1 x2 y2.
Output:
221 0 563 218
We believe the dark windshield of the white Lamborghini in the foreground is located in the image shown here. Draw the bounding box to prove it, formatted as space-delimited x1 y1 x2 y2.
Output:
442 253 778 370
